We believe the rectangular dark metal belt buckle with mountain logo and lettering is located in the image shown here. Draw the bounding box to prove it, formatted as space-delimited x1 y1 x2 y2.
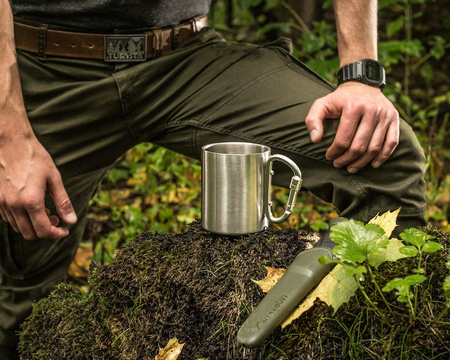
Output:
105 34 147 62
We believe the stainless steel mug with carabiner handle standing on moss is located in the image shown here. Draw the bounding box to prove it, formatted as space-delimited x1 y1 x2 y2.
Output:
202 142 302 235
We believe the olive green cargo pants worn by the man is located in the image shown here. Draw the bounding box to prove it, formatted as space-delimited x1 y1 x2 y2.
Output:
0 29 425 359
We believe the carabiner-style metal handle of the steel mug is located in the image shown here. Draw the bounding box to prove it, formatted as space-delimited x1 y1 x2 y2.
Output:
265 154 302 224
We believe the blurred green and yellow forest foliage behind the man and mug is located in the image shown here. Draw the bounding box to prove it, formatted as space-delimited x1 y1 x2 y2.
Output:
90 0 450 261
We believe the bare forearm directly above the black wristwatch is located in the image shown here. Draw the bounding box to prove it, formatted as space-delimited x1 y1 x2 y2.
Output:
334 0 378 67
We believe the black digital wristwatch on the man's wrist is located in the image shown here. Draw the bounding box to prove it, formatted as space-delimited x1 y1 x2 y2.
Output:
338 59 386 89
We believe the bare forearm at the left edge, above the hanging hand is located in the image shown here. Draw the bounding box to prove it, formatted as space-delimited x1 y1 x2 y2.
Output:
0 0 32 140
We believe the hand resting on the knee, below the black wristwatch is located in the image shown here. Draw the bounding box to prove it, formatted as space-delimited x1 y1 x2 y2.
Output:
305 82 400 174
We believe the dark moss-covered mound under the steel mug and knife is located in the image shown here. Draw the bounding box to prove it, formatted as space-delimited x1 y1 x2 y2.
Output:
20 223 450 360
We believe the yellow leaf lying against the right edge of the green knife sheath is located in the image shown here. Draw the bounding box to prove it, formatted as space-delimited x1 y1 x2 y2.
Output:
281 264 358 329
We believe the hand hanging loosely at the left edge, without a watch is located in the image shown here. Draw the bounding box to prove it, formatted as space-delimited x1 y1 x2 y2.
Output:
0 137 77 240
